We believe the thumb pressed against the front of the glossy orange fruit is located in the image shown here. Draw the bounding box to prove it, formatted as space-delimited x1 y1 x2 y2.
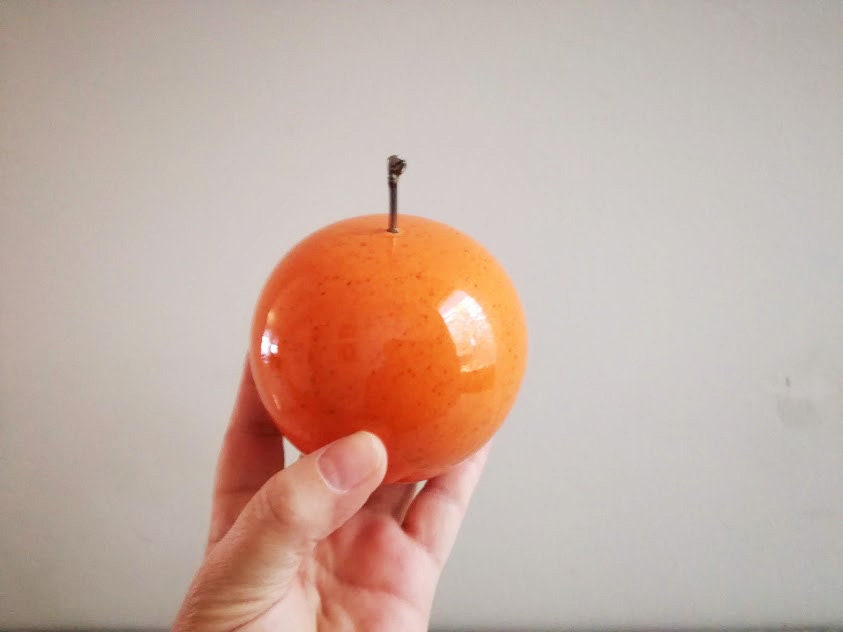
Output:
183 432 387 629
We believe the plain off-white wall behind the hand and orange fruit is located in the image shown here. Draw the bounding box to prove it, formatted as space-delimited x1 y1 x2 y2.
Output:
0 1 843 629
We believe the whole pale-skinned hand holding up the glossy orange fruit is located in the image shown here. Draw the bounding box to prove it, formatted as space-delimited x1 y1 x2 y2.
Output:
173 364 488 632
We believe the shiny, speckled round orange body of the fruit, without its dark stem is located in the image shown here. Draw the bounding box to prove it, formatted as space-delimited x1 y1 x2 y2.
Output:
249 215 527 483
